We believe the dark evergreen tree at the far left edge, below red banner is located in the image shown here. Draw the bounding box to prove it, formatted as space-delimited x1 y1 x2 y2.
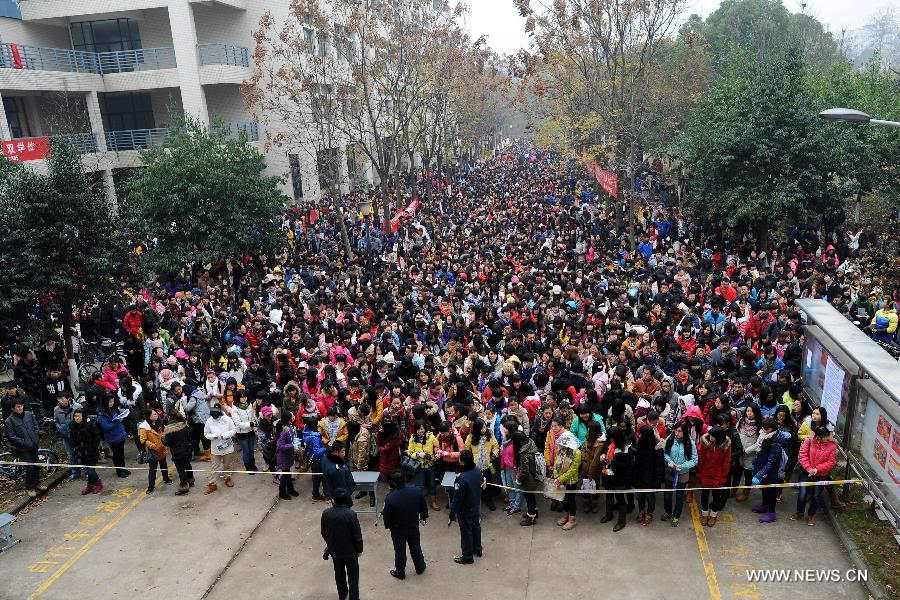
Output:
0 138 130 380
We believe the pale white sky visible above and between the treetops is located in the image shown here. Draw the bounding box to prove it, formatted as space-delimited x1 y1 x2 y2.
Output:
468 0 900 54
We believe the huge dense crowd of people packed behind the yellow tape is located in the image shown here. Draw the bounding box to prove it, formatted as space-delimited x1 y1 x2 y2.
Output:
2 146 897 540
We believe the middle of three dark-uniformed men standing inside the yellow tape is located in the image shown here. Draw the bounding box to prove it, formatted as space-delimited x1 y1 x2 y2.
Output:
381 471 428 579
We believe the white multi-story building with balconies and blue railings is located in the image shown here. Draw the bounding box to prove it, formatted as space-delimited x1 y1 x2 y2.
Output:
0 0 371 200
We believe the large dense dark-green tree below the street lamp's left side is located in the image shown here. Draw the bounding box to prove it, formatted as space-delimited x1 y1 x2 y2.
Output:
675 48 844 239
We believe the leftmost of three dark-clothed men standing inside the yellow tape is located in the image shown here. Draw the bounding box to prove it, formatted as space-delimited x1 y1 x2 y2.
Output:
322 488 363 600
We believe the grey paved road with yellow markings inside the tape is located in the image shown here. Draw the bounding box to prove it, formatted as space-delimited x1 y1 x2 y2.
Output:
0 463 867 600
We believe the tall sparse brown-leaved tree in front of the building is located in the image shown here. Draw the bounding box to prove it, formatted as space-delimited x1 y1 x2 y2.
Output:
244 0 465 227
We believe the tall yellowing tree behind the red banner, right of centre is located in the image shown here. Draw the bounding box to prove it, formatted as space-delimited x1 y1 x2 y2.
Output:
516 0 706 245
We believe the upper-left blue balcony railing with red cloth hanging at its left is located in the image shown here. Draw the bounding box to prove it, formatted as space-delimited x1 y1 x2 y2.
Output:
0 44 177 75
